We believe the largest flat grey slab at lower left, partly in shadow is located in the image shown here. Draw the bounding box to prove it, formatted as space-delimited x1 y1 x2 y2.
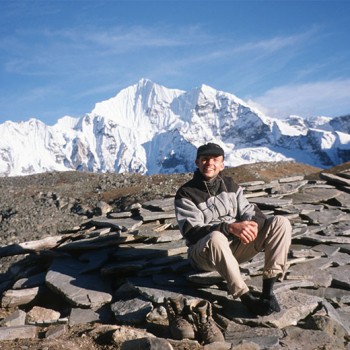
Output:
46 258 112 309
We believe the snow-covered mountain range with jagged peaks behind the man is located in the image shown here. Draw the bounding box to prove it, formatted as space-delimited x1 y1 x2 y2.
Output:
0 79 350 176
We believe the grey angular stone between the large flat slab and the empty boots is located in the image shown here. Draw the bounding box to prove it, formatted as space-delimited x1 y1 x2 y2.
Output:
111 298 153 324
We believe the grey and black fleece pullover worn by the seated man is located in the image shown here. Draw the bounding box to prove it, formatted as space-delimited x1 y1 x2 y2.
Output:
175 170 266 245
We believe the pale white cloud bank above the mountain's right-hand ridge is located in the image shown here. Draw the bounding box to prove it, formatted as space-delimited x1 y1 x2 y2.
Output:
249 79 350 118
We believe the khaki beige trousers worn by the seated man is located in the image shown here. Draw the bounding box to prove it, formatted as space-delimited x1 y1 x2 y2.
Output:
188 215 292 298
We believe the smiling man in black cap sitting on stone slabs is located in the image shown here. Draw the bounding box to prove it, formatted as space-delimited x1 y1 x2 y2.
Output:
175 143 292 315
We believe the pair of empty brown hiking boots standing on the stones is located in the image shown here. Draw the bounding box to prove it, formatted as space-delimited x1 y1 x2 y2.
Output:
165 297 225 344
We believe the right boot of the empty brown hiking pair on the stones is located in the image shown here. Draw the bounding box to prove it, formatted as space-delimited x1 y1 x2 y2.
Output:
190 300 225 344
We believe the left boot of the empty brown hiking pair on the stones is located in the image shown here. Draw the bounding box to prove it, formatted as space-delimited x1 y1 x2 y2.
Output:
165 297 195 340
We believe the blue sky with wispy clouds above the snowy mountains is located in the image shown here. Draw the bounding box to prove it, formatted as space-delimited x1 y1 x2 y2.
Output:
0 0 350 125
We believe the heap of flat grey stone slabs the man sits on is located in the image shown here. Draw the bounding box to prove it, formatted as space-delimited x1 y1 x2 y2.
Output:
0 170 350 350
